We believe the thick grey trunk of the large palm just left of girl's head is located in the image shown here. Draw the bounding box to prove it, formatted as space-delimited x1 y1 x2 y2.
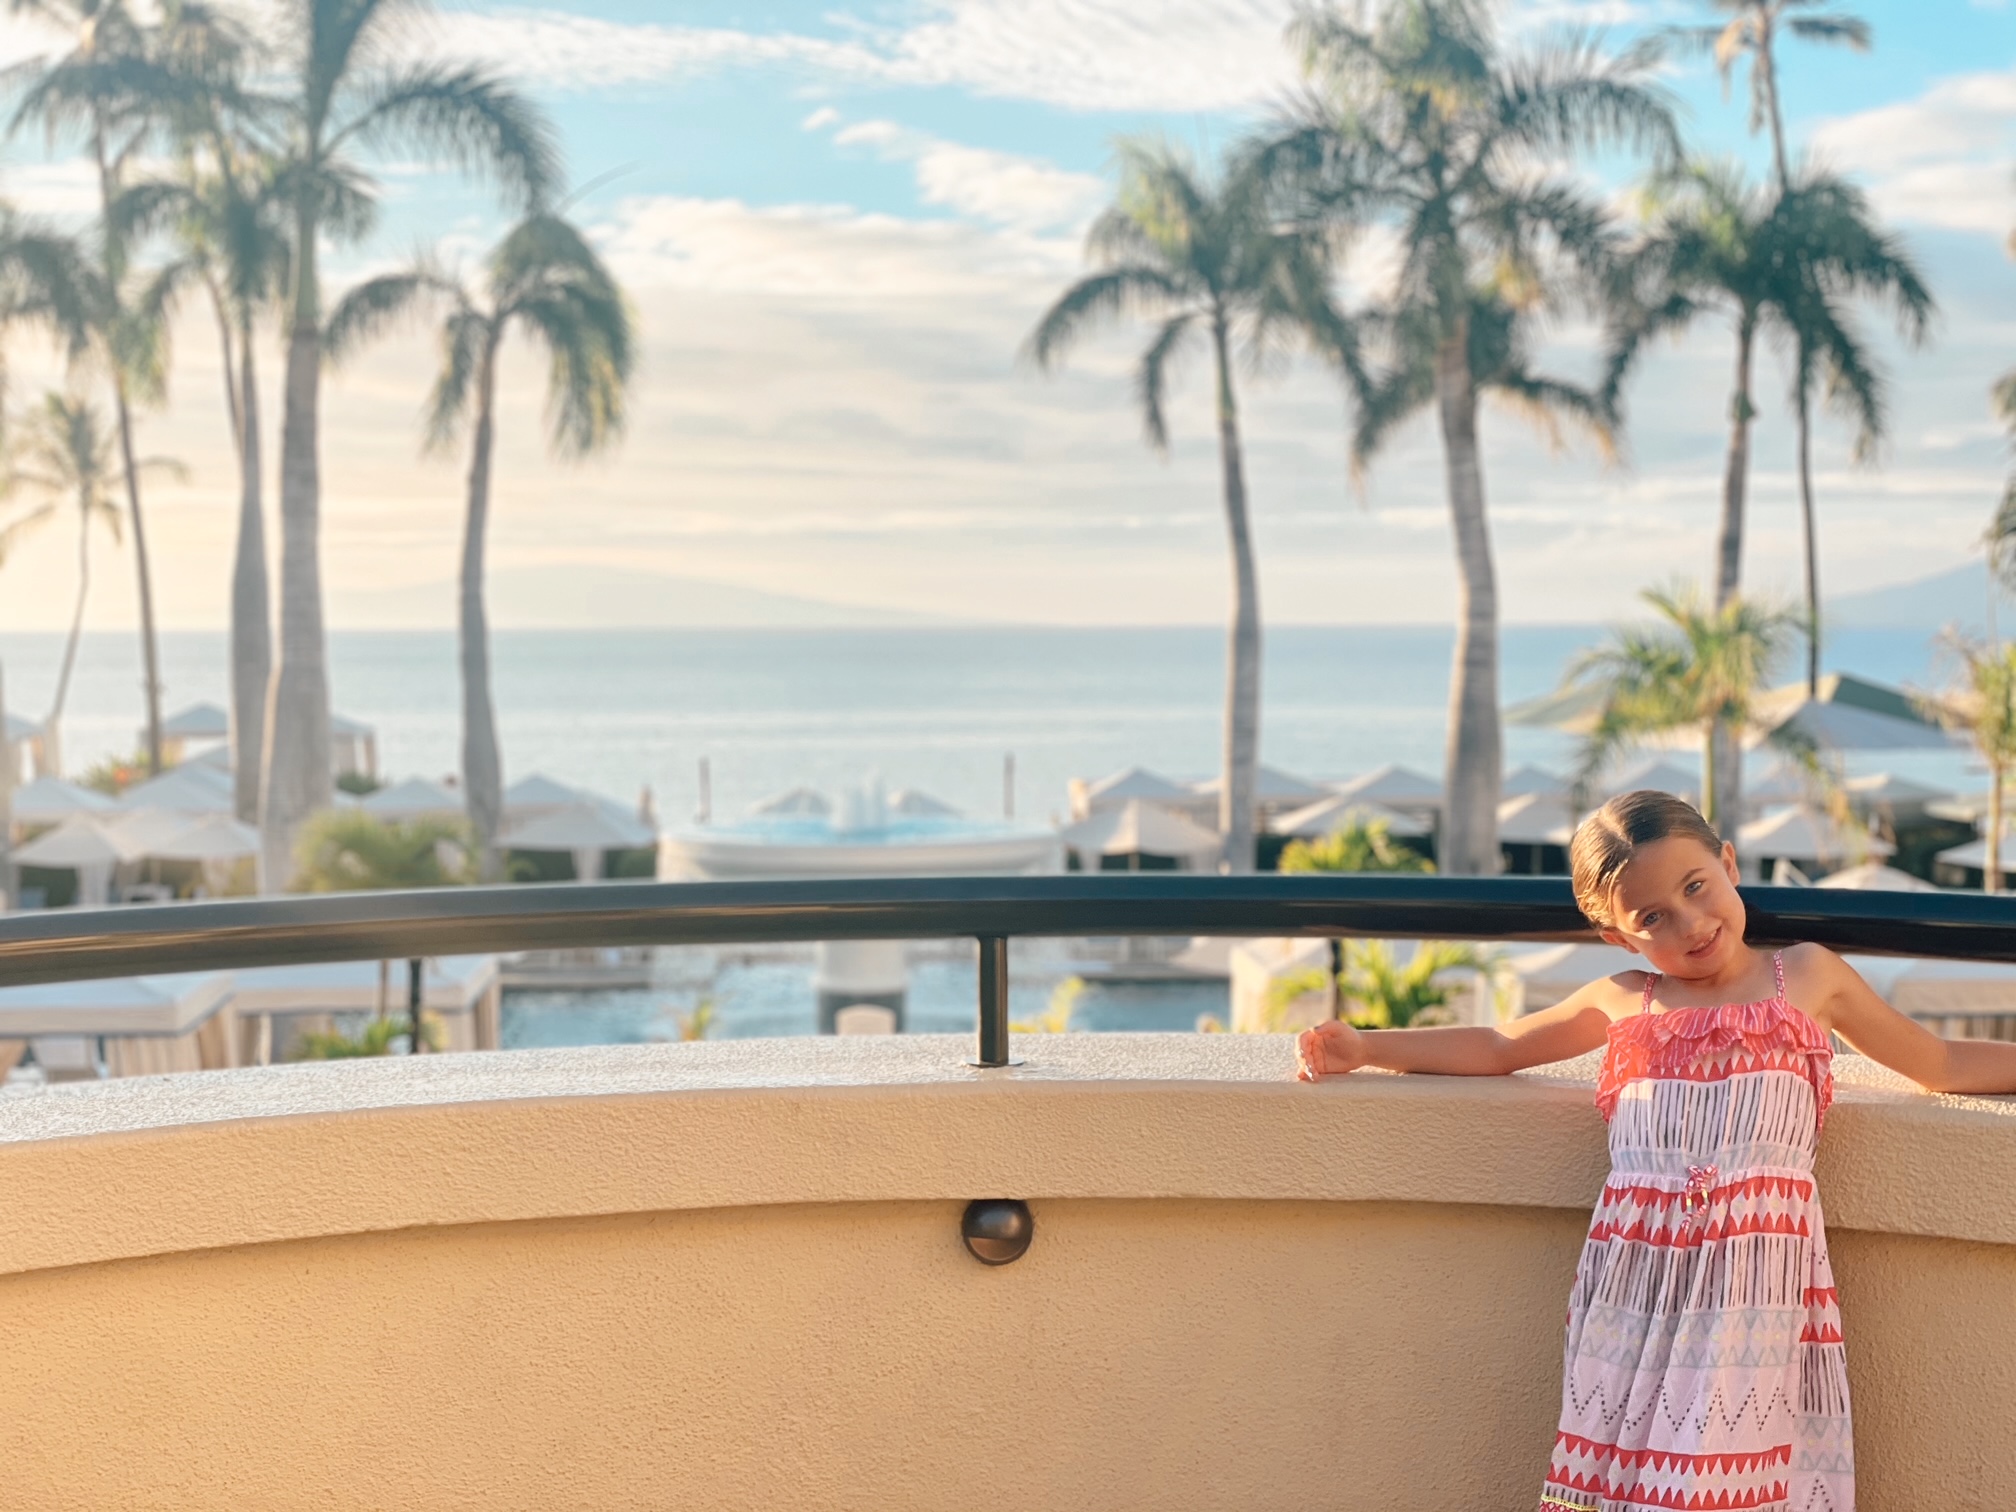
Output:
1435 319 1504 877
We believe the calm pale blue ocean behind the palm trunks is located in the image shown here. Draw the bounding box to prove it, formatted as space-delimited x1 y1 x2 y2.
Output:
0 625 1968 827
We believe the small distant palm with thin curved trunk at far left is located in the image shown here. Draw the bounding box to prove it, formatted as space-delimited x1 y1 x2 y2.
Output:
0 393 179 772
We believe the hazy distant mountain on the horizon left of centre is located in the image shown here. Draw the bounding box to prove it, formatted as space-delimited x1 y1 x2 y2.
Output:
329 562 970 629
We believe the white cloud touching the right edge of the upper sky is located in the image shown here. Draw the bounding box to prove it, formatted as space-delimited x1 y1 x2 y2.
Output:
1812 69 2016 232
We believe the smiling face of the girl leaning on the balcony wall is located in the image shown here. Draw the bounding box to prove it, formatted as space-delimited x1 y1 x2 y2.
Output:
1603 835 1744 980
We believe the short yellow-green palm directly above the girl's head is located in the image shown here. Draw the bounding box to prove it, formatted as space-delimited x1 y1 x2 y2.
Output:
1564 589 1818 829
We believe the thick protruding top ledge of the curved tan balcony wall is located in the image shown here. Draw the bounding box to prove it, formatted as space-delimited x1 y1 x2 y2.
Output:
0 1034 2016 1274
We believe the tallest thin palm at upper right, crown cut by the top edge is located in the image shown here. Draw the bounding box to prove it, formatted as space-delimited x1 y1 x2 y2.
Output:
1667 0 1871 696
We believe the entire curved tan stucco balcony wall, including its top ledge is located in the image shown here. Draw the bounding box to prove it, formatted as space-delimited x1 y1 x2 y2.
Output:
0 1036 2016 1512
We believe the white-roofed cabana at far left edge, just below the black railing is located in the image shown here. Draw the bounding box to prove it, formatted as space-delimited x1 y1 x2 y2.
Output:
0 972 238 1079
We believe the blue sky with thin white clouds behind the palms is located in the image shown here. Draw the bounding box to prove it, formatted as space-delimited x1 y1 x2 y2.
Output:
0 0 2016 627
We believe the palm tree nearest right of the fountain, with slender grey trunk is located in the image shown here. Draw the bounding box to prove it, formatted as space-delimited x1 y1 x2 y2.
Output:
1026 141 1337 873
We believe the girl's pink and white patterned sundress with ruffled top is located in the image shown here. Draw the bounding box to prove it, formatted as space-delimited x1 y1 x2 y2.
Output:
1540 956 1855 1512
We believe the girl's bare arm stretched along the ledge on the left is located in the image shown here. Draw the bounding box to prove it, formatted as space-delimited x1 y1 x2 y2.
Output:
1294 980 1620 1081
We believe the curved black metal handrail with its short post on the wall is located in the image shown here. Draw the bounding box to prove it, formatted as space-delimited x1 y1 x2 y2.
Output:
0 875 2016 1066
